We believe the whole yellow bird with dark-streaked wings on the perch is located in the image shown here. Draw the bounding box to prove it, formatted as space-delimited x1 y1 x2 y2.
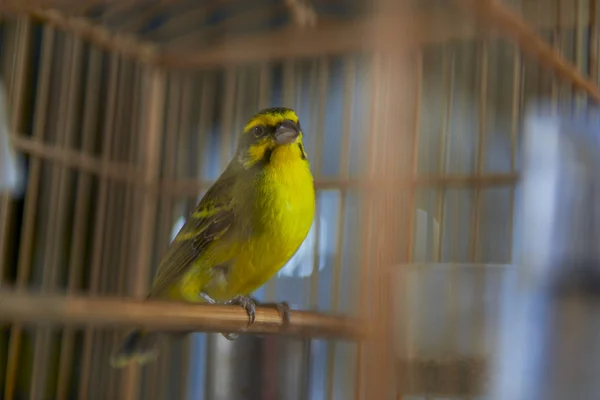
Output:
111 108 315 367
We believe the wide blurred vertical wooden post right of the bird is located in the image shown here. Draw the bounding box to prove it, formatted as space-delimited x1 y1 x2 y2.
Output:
363 45 414 399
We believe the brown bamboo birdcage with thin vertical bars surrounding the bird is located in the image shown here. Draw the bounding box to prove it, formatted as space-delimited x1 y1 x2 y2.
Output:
0 0 600 400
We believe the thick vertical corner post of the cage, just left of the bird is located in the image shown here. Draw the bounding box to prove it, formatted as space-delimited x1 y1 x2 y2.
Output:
123 67 165 399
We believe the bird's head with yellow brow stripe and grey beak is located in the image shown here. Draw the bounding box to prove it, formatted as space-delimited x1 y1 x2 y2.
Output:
237 107 308 169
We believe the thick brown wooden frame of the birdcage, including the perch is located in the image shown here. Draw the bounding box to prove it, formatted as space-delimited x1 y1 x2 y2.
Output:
0 0 600 399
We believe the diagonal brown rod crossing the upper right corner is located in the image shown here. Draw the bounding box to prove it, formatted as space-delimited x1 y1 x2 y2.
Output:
454 0 600 102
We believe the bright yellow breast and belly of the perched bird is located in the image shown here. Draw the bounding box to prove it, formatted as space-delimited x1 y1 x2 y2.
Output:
173 144 315 301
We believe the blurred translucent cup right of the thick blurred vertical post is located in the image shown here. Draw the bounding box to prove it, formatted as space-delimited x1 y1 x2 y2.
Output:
390 264 516 397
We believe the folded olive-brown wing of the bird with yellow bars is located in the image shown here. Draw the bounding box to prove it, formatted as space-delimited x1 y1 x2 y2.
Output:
148 176 234 297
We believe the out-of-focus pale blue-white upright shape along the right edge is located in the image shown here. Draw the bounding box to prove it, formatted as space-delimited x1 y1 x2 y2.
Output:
493 107 600 400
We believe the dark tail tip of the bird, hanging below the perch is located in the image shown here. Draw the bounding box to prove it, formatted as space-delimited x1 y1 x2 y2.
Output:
110 330 160 368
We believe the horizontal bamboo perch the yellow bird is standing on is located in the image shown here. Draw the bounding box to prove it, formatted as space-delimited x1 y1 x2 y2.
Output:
0 289 368 340
